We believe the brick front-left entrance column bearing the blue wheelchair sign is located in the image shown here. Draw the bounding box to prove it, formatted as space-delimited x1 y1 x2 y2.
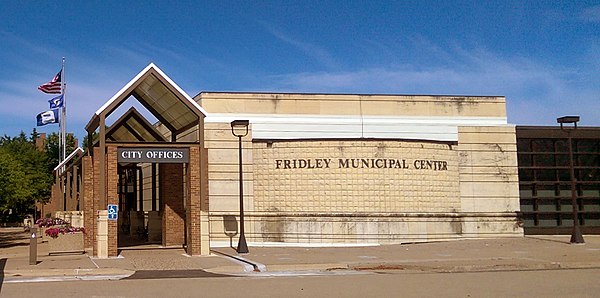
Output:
106 146 119 257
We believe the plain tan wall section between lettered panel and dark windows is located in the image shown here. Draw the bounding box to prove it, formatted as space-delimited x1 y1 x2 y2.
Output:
458 126 523 236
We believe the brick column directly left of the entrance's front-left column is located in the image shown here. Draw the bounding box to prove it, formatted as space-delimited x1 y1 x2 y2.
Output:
80 156 96 248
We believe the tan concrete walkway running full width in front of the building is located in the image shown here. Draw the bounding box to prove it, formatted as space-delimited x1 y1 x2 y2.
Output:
0 228 600 282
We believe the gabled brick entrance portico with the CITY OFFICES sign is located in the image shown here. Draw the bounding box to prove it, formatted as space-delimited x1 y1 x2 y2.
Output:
84 64 209 257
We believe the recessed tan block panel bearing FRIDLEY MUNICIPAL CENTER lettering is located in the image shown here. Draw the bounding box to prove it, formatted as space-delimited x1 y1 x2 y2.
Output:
253 141 460 212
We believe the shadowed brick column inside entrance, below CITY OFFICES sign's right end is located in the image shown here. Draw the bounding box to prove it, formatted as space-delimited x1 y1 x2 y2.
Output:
159 164 185 246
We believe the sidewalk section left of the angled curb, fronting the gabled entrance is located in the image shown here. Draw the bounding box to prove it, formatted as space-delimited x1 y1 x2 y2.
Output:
0 228 245 282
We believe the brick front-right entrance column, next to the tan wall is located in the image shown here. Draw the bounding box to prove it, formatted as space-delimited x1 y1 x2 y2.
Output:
185 147 202 255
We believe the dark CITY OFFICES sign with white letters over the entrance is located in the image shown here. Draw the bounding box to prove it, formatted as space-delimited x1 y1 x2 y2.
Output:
117 147 190 163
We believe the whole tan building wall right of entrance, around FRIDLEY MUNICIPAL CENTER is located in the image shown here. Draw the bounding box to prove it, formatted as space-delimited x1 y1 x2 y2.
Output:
200 92 522 245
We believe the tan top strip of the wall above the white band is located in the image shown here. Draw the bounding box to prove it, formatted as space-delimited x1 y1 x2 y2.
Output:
195 92 506 117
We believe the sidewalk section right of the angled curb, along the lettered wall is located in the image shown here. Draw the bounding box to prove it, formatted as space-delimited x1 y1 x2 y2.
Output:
213 236 600 272
